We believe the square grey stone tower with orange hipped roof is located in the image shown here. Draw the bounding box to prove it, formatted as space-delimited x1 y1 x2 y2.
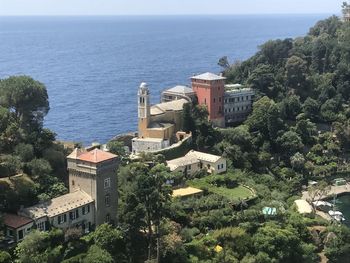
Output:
67 149 119 226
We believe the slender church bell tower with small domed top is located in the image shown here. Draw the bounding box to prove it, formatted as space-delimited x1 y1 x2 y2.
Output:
137 82 151 138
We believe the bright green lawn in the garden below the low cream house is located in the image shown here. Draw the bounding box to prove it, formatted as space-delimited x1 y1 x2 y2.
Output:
187 176 255 200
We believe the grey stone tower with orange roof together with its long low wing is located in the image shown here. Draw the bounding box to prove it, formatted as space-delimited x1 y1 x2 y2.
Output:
11 148 119 240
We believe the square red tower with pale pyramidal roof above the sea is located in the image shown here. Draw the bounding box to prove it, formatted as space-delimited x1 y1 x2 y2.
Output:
191 72 226 127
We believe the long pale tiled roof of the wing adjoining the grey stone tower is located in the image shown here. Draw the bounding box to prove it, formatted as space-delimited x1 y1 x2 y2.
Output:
22 190 94 219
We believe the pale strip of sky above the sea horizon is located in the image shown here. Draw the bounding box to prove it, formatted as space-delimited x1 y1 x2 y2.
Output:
0 0 344 16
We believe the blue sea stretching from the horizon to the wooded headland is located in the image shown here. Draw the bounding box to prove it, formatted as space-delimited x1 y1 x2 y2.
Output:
0 15 328 144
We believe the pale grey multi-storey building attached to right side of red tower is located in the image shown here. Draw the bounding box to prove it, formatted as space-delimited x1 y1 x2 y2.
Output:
224 84 255 125
